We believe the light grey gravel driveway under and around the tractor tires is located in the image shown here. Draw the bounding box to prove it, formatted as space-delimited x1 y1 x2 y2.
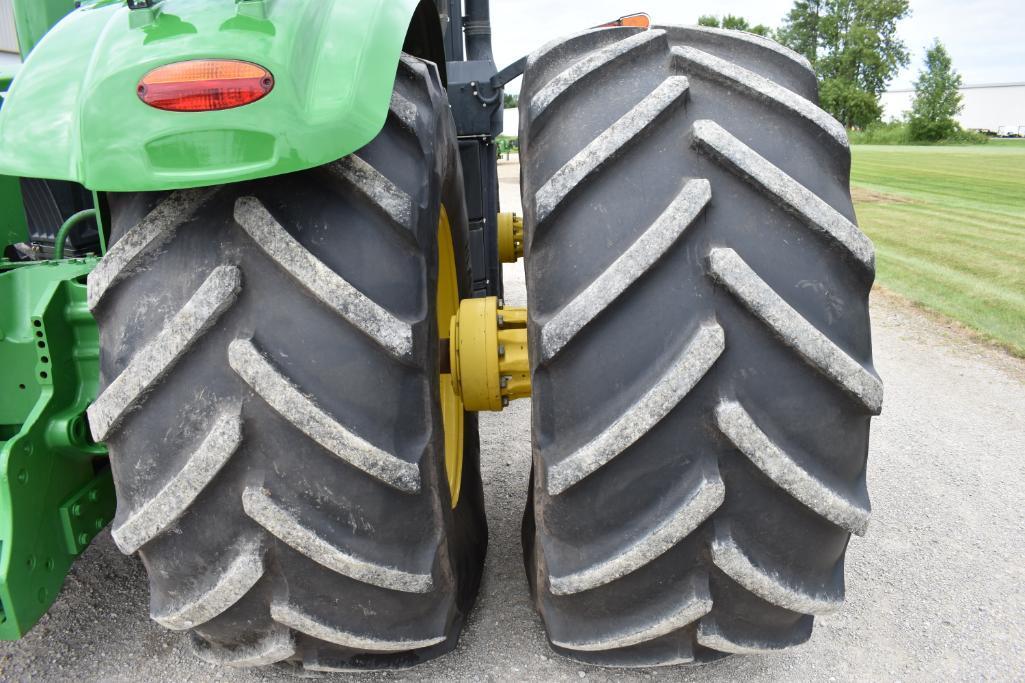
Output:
0 159 1025 682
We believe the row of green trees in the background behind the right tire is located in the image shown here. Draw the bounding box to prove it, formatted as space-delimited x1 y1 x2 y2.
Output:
698 0 961 140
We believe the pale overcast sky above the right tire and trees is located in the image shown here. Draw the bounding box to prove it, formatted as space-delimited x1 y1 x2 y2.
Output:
491 0 1025 92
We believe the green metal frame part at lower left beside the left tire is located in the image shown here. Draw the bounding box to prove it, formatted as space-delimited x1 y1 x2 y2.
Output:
0 258 109 640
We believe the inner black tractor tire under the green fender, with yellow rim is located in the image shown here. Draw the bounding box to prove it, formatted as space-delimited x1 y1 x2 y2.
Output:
89 56 487 671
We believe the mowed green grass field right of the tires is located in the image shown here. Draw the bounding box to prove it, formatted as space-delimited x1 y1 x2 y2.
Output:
851 140 1025 357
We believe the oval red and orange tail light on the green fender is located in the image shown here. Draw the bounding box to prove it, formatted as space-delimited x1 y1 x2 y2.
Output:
138 59 274 112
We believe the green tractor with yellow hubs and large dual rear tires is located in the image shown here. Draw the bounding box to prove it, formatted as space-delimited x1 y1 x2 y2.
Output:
0 0 883 671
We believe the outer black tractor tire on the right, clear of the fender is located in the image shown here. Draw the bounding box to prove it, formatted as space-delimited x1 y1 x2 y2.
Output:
521 28 883 666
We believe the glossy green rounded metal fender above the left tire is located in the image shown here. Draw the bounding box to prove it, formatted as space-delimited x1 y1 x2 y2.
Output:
0 0 418 192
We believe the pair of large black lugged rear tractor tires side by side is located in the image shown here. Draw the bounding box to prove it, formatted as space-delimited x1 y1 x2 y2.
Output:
90 28 882 671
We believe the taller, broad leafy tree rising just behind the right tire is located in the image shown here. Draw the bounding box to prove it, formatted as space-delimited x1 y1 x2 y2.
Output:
777 0 910 128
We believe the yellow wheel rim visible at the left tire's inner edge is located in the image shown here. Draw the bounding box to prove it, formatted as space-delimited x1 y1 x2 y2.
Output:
438 206 464 508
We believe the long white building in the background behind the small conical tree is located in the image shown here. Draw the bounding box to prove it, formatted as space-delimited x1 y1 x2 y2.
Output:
880 83 1025 135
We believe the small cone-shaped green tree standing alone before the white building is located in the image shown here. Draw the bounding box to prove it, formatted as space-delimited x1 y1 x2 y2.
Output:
907 39 964 142
